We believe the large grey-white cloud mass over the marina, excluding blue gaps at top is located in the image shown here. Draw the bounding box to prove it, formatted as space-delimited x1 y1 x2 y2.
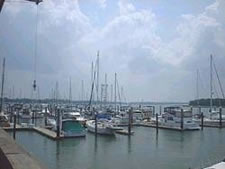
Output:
0 0 225 101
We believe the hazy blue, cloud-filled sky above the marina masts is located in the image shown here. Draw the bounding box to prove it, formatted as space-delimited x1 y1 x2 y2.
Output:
0 0 225 102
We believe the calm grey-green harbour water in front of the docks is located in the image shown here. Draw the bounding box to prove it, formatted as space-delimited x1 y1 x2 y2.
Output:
7 127 225 169
